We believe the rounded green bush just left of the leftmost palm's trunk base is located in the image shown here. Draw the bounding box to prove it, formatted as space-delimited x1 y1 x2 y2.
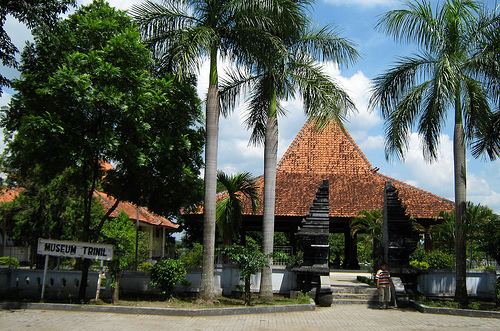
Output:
151 259 187 298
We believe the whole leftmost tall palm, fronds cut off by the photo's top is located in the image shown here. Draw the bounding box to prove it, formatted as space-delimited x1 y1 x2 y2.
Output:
130 0 293 300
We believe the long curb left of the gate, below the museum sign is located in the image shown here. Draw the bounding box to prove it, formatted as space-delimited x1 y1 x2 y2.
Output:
0 302 316 316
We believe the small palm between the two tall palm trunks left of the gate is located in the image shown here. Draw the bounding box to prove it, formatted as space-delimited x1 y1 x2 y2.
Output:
216 171 259 246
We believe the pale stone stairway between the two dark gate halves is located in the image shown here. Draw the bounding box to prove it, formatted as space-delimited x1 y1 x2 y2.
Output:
330 272 378 305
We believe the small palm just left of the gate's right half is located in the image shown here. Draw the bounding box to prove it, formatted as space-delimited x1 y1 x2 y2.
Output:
351 209 384 268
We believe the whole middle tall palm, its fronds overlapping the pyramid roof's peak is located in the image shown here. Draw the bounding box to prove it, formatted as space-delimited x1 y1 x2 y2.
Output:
221 1 358 299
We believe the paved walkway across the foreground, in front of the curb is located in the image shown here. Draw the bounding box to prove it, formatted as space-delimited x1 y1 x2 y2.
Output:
0 305 500 331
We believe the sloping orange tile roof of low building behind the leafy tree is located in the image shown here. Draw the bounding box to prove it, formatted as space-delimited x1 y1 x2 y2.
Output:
94 190 179 230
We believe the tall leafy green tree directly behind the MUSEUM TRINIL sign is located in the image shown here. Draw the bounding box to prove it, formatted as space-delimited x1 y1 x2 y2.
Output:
2 0 203 300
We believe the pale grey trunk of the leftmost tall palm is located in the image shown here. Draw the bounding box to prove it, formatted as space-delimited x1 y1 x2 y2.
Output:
200 47 219 300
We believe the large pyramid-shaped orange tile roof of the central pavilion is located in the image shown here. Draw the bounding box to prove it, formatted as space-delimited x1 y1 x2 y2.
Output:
245 122 453 219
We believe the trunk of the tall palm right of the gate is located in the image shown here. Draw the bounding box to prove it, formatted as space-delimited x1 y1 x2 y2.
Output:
453 90 468 308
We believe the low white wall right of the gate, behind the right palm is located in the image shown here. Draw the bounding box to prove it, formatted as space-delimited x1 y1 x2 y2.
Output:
417 271 497 300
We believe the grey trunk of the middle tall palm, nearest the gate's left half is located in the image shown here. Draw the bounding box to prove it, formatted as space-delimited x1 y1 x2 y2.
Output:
260 84 278 300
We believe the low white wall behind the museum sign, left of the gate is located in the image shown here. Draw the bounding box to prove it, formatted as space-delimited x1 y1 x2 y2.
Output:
0 265 296 301
